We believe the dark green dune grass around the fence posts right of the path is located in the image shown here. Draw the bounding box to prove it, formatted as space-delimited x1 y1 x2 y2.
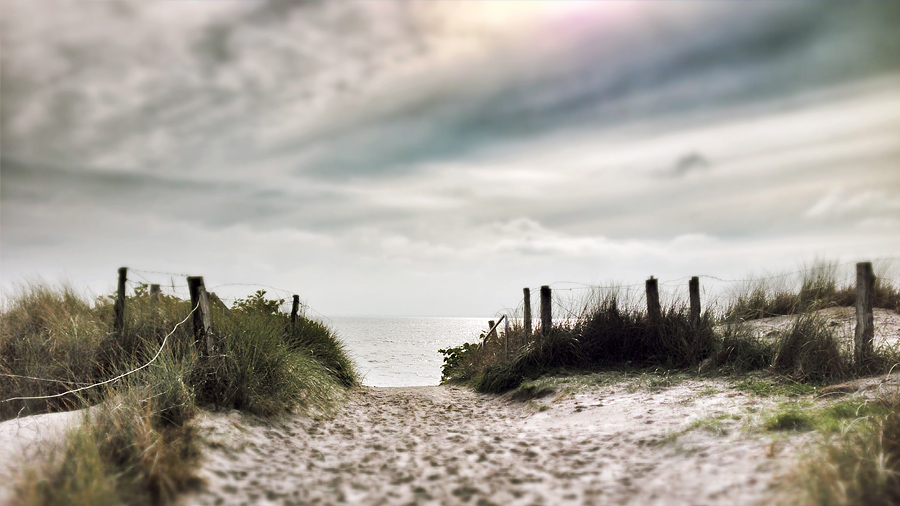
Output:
441 262 900 393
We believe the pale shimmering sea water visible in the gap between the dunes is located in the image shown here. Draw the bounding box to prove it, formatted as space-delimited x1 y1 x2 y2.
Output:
325 317 488 387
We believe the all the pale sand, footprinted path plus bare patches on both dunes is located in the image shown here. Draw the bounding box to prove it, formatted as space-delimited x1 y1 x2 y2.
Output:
0 309 900 506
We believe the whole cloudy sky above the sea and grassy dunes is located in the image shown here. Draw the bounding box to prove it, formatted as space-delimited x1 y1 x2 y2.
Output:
0 0 900 316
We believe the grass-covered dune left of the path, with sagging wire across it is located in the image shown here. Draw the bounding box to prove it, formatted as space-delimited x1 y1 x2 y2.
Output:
0 283 358 504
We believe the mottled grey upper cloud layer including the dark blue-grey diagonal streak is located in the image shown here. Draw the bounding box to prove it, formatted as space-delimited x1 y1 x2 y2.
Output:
2 1 900 179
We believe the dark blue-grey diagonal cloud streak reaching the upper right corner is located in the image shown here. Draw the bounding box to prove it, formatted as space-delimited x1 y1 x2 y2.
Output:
282 2 900 179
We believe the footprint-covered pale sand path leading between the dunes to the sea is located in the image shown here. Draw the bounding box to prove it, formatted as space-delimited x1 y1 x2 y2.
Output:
181 384 783 505
